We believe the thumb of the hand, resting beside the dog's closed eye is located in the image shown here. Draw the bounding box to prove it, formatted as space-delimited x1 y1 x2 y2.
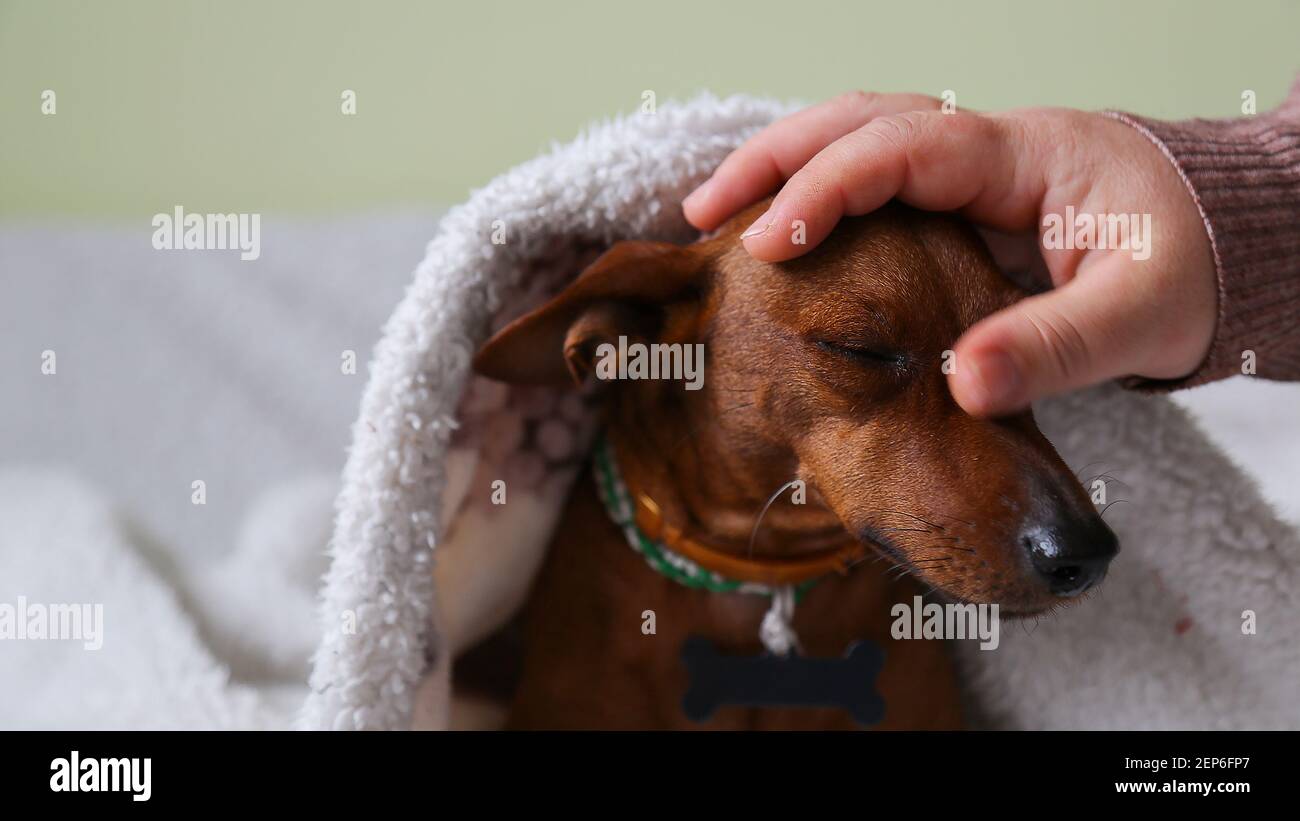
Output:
948 270 1149 417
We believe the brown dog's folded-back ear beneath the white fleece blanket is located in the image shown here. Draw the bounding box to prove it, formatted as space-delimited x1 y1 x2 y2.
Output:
473 240 707 385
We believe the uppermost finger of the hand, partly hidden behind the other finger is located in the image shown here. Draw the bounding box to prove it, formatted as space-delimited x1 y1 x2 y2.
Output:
681 91 940 231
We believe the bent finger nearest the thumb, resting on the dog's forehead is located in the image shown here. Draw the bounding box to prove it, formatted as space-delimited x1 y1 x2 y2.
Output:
742 112 1045 261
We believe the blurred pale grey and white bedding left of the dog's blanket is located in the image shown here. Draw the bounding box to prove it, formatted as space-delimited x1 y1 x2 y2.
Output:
0 212 426 729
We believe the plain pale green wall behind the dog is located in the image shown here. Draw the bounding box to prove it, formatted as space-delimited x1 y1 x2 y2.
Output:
0 0 1300 220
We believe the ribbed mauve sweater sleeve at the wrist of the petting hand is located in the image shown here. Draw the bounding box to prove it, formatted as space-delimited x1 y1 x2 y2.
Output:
1109 78 1300 390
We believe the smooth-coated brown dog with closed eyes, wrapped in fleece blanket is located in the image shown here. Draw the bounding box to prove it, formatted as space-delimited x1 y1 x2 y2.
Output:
475 203 1117 729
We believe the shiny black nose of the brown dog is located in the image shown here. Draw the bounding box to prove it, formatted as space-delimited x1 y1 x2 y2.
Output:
1022 517 1119 599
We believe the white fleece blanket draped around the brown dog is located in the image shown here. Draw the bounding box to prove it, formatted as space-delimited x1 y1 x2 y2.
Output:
302 97 1300 729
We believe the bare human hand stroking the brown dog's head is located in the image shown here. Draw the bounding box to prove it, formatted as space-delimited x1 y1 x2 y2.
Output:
683 94 1218 416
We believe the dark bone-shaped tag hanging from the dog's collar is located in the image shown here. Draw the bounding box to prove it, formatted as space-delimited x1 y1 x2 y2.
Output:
681 635 885 726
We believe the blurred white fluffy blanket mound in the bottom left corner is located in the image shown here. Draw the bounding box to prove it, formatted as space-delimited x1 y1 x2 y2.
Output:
0 469 302 730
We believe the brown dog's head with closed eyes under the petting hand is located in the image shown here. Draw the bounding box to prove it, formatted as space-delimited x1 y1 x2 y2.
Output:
475 203 1118 613
